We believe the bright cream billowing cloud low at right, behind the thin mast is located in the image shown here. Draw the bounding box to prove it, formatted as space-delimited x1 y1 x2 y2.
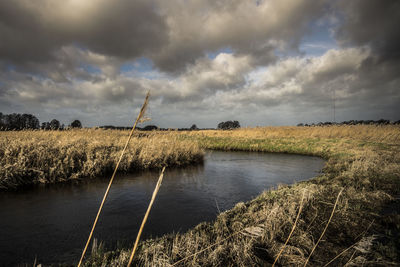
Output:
196 48 400 121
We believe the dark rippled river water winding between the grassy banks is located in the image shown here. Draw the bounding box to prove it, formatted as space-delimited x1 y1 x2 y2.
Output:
0 151 324 266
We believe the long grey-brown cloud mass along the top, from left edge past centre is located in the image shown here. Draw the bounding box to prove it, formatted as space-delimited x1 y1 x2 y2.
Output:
0 0 322 72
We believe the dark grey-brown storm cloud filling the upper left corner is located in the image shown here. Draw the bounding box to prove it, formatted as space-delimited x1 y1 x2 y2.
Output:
0 0 167 64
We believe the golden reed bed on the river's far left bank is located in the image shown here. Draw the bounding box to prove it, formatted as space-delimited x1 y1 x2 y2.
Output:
0 129 203 190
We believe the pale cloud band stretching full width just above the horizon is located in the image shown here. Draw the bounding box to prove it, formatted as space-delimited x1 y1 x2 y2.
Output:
0 45 400 127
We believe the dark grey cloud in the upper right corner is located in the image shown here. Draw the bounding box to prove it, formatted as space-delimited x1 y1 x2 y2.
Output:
336 0 400 90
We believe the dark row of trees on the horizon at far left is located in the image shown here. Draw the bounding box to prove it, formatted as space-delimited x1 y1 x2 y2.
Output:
0 112 82 131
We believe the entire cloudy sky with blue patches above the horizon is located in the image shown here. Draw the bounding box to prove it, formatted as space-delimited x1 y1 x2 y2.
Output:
0 0 400 128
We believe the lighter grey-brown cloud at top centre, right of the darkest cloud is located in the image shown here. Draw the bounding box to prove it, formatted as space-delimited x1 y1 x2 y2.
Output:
152 0 322 72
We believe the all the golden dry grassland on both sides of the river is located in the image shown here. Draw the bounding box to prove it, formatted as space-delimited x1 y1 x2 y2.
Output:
0 125 400 266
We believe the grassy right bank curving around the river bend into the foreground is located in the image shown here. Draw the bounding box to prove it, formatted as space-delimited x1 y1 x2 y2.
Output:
85 126 400 266
